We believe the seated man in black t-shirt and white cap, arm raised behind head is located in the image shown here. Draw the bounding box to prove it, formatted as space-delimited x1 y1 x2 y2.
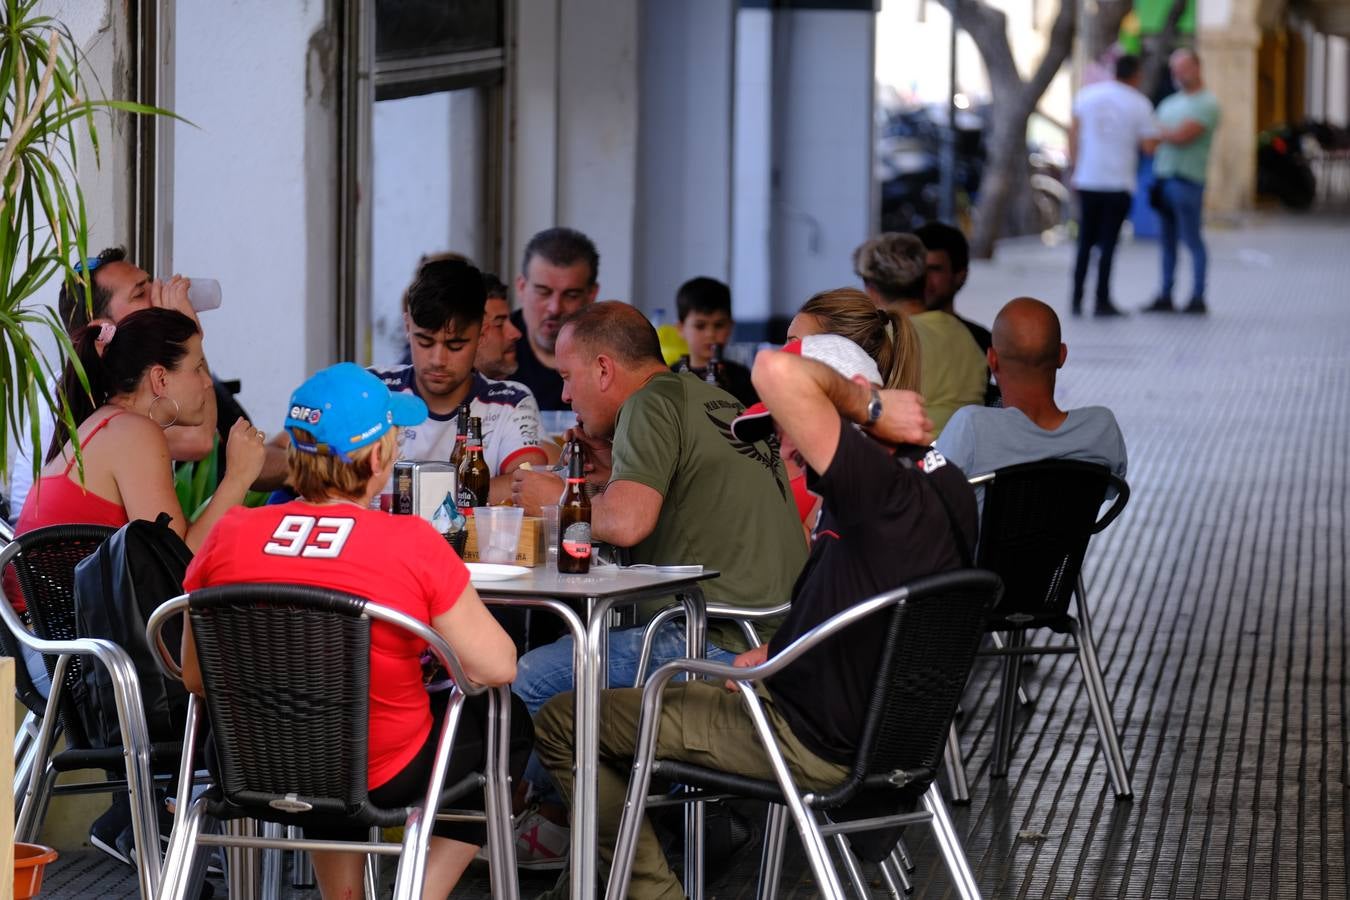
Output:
535 335 976 900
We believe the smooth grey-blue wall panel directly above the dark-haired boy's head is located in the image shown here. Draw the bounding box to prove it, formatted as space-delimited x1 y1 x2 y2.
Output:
632 0 740 321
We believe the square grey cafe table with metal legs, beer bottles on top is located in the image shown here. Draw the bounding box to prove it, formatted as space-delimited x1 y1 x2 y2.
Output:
474 565 717 900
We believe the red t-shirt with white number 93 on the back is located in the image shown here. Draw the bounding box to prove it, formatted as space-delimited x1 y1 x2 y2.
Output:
184 501 468 788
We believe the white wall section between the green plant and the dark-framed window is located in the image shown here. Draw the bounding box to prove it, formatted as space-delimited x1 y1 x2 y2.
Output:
173 0 336 432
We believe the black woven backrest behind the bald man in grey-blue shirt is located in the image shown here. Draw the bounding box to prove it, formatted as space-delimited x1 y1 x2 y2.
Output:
976 460 1130 630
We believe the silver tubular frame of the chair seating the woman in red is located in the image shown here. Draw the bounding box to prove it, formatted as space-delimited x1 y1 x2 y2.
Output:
146 584 520 900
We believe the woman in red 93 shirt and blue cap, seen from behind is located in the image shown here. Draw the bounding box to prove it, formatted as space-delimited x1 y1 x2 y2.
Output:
182 363 533 900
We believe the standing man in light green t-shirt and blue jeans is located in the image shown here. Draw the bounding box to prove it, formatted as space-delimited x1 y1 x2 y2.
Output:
1145 49 1219 314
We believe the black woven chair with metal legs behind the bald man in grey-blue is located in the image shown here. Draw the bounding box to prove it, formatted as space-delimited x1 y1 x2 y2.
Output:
946 460 1134 801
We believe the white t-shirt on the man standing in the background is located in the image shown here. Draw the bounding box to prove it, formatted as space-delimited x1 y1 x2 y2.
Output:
1073 80 1158 193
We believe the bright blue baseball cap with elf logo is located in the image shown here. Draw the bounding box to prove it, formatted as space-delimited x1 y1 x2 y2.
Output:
286 363 427 463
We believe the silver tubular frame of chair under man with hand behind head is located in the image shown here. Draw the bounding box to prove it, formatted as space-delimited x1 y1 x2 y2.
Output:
605 571 998 900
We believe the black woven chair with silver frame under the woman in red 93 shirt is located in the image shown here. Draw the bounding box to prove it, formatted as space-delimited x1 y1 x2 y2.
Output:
146 584 518 900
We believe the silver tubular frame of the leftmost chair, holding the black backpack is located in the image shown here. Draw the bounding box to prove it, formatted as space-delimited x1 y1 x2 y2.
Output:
0 525 161 899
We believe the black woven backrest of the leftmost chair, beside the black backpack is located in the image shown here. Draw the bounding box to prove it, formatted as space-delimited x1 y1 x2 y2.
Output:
14 525 116 748
